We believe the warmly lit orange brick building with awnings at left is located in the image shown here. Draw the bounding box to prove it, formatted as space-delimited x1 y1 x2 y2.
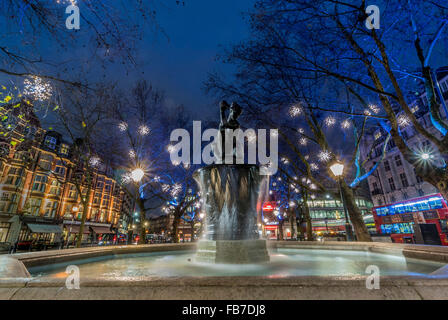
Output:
0 101 132 248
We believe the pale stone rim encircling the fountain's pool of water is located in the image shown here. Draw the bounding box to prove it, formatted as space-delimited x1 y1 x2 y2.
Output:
0 241 448 300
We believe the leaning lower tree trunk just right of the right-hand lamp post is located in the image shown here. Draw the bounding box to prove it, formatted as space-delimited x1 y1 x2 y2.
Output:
341 180 372 242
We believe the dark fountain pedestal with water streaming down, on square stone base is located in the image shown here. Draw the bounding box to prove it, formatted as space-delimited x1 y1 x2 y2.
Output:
194 164 269 263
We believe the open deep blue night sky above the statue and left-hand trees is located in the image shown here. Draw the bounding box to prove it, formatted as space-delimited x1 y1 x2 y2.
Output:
0 0 255 119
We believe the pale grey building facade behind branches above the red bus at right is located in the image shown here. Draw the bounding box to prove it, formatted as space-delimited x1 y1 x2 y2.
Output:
361 75 448 206
